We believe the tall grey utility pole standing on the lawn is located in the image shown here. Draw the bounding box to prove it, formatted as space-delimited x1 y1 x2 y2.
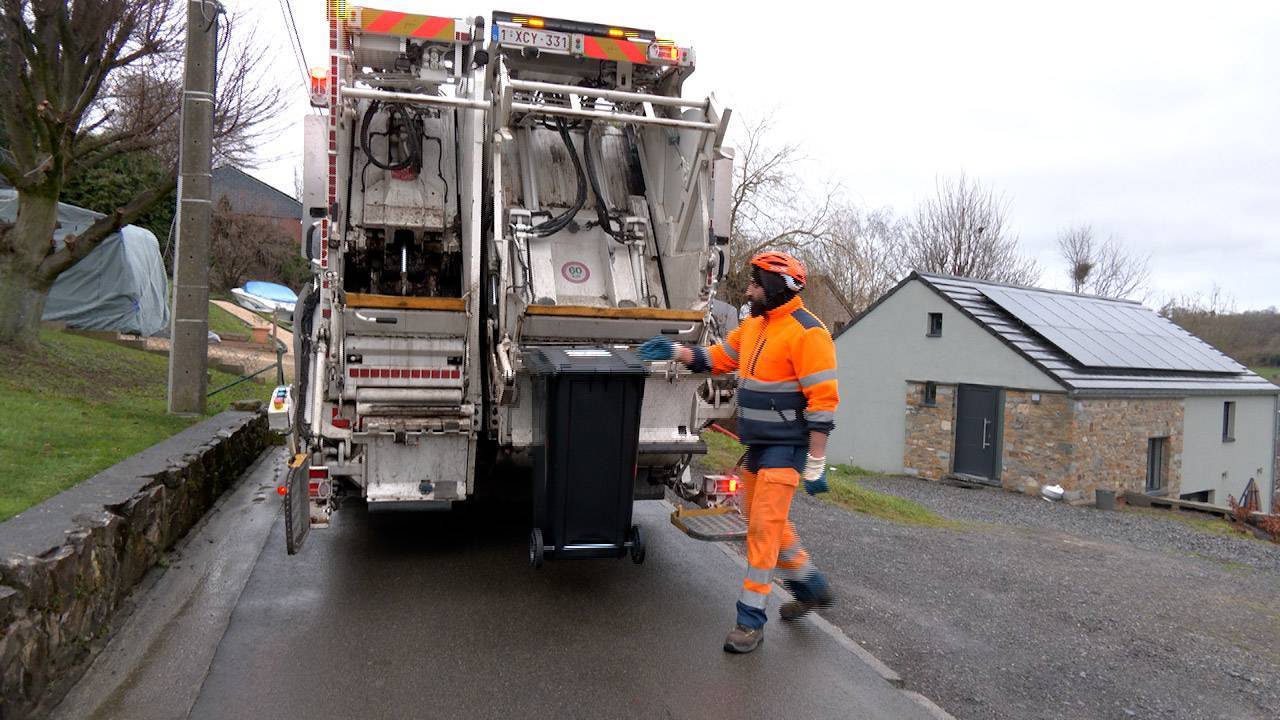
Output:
169 0 223 415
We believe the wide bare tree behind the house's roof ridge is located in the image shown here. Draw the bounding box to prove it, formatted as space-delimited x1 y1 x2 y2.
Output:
902 174 1039 284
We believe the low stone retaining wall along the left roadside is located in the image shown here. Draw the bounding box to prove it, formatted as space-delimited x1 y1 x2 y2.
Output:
0 410 269 720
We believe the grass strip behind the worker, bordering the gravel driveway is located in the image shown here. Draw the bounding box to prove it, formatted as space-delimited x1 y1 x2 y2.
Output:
703 430 959 528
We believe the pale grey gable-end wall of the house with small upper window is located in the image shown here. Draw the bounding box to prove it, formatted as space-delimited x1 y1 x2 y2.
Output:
827 279 1065 473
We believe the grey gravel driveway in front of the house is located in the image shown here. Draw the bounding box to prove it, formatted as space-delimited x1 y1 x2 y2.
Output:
706 466 1280 720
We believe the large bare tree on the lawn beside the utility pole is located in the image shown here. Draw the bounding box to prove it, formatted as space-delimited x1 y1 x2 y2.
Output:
0 0 279 348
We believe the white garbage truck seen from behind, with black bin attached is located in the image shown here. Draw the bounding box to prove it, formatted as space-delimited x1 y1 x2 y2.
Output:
280 8 733 565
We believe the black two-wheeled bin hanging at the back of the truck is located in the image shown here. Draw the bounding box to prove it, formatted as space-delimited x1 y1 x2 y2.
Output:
525 347 645 568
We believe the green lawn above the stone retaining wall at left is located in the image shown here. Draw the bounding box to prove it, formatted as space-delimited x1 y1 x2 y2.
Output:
0 331 269 520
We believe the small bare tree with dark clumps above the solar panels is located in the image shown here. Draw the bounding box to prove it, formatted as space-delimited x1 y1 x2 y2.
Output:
1057 224 1151 300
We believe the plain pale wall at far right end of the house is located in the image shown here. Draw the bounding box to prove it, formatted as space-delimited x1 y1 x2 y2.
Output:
1181 396 1276 509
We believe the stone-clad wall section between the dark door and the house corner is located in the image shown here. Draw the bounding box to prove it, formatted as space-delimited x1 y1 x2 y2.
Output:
1000 389 1074 491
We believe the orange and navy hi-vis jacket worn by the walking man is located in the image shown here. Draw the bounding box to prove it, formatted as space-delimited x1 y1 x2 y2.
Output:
690 296 840 445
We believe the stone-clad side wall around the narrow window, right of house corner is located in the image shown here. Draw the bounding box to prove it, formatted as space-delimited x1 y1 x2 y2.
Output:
1062 398 1184 498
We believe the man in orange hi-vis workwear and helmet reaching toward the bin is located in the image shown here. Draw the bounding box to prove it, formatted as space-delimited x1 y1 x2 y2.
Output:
640 252 840 652
